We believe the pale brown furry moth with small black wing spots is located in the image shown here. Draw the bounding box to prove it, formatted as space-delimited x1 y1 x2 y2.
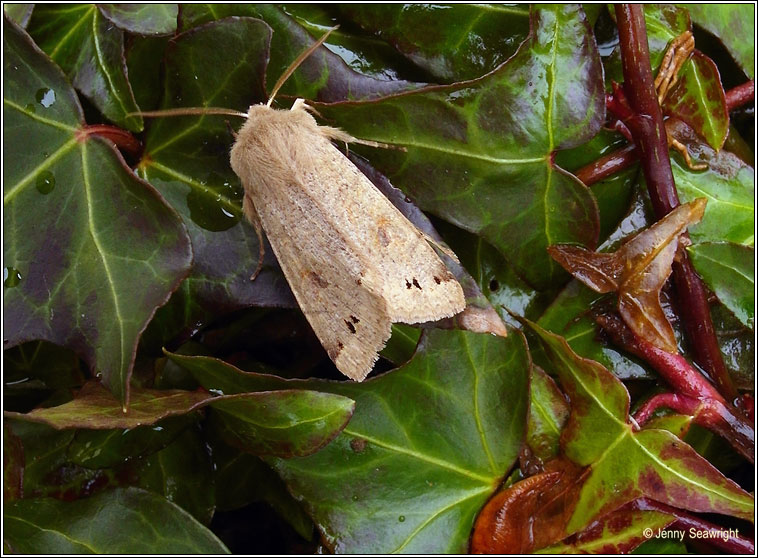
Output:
144 28 466 381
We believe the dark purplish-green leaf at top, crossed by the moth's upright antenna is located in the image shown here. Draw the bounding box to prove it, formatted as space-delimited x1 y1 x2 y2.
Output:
179 4 417 102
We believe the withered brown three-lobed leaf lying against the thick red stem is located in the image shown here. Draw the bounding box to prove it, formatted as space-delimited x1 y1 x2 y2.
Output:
548 198 706 353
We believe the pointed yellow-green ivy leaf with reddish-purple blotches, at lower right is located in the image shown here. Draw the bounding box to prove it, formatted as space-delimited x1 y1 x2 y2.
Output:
530 324 754 535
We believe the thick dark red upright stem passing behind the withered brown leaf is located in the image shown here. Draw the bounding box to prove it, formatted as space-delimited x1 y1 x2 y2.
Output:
615 4 738 401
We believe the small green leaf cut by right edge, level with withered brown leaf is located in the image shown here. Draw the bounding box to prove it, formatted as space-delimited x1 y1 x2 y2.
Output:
687 243 755 329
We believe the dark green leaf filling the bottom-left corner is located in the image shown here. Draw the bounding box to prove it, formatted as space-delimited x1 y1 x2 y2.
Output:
3 488 228 554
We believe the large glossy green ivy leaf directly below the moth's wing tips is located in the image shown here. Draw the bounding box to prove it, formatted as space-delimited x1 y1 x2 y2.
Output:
171 330 529 553
